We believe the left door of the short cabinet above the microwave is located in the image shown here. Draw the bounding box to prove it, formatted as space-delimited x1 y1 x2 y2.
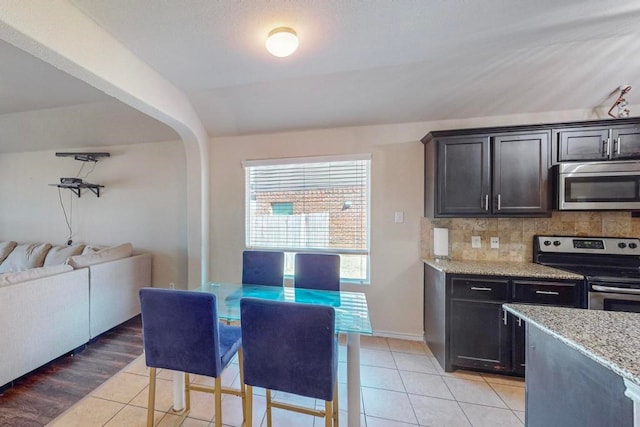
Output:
558 127 613 162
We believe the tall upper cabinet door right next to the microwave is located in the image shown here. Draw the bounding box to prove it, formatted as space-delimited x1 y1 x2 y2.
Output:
492 132 549 215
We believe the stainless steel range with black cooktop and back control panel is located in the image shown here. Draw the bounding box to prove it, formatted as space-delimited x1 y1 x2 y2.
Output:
533 236 640 313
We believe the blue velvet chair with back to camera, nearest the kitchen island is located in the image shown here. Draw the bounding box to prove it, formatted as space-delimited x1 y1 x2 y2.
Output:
240 298 338 427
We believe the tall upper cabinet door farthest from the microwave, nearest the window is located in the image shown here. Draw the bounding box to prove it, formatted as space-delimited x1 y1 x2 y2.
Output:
436 136 490 216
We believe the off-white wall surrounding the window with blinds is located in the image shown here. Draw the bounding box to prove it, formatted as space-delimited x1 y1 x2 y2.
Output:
211 125 425 338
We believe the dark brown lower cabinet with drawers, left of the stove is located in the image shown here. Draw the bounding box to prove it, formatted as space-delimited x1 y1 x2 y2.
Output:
424 265 586 376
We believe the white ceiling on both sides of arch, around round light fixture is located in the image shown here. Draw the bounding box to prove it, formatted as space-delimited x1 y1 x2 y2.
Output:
0 0 640 152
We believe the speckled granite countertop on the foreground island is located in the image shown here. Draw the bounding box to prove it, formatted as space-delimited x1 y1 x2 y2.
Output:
503 304 640 385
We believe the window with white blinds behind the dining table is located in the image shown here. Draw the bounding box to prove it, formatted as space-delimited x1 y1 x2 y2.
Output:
244 155 371 282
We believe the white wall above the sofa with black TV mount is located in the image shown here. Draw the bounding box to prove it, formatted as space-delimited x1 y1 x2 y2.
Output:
0 141 187 288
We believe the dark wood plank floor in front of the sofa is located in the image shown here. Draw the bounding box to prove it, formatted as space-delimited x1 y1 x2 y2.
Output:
0 316 142 427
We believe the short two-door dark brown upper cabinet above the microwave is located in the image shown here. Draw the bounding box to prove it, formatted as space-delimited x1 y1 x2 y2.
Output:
554 124 640 162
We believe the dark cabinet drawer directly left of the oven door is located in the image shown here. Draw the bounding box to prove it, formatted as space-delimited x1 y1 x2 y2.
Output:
513 281 581 307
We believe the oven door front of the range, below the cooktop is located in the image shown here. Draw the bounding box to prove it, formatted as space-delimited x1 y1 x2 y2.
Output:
589 282 640 313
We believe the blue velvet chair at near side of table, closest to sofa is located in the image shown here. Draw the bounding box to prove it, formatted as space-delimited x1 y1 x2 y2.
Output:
140 288 246 427
